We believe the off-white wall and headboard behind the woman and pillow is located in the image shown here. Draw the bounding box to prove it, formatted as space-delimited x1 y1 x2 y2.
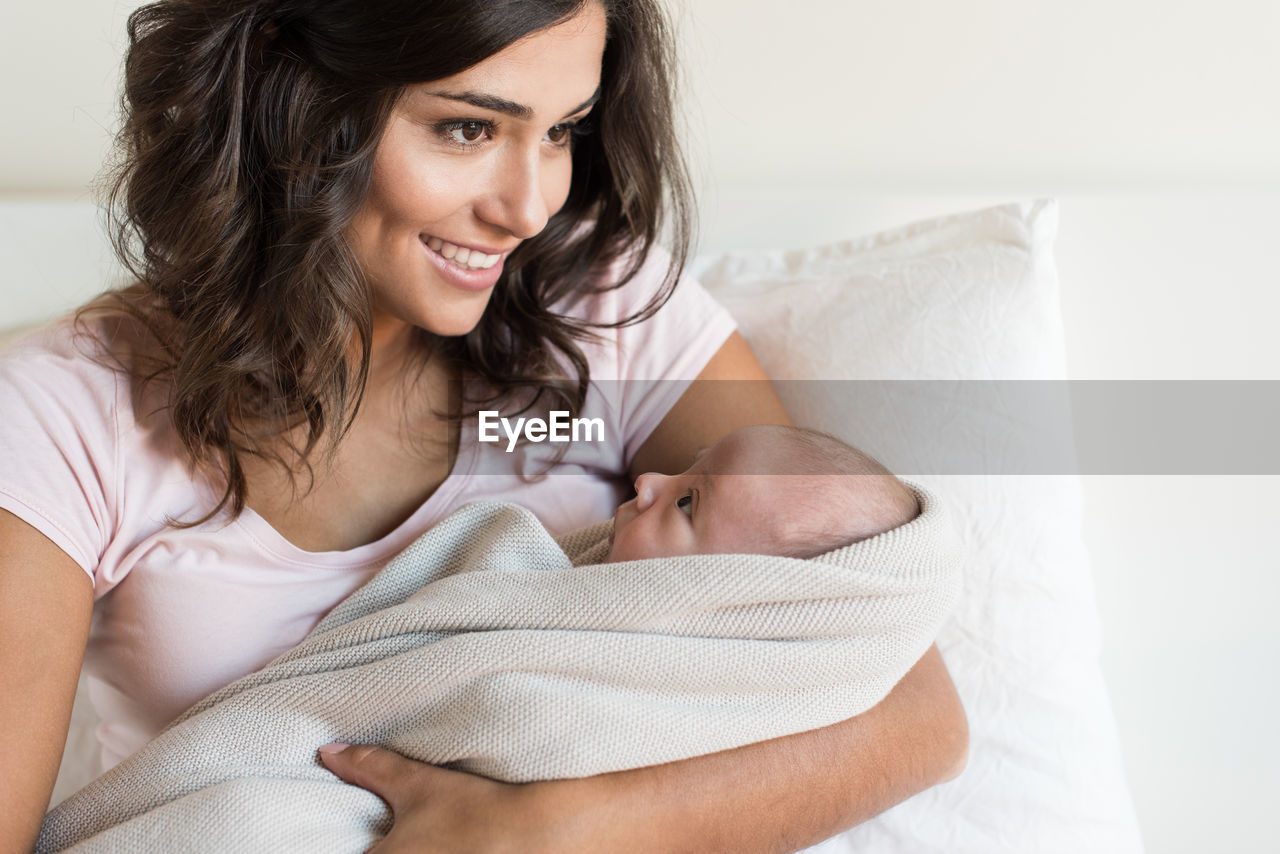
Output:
0 0 1280 853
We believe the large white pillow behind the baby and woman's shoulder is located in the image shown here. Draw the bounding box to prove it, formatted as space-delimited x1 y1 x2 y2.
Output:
691 200 1142 854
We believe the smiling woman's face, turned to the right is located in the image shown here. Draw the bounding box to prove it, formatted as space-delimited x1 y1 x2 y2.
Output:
347 3 605 341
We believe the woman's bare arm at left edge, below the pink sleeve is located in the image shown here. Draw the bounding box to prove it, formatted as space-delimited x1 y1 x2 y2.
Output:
0 510 93 854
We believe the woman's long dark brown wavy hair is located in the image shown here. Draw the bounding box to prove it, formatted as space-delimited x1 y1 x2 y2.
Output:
88 0 692 524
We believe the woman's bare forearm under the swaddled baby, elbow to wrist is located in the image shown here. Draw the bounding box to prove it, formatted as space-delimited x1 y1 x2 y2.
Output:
534 648 968 854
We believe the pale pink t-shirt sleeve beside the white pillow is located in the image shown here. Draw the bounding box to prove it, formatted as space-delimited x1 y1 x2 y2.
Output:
576 240 737 461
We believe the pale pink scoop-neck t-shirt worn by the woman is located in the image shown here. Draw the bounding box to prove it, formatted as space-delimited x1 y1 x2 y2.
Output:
0 245 733 767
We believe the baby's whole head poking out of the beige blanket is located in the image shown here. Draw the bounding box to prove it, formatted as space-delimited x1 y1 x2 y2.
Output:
608 426 920 561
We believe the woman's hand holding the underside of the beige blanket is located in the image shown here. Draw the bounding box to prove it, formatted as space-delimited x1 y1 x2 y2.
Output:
320 745 557 854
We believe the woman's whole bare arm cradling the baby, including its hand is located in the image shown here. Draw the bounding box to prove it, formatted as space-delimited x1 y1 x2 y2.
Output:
321 334 968 854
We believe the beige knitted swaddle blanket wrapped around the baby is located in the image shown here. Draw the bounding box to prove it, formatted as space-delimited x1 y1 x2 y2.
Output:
37 487 959 854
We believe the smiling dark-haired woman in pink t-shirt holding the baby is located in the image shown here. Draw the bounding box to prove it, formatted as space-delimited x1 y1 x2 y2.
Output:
0 0 965 851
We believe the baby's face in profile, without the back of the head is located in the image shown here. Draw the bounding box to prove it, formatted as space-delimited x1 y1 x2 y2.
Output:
607 428 806 561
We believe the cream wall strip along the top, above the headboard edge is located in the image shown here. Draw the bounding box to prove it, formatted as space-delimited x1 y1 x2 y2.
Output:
0 0 1280 193
